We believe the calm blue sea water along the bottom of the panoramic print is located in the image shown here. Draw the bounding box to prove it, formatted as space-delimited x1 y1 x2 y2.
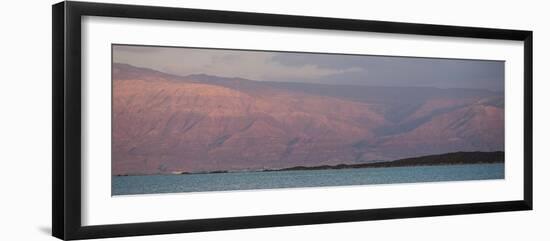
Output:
111 163 504 195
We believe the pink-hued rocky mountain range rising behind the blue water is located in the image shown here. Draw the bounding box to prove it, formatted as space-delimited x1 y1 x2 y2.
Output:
112 64 504 175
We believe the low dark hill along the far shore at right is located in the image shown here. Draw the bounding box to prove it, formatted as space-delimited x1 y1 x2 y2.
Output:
272 151 504 171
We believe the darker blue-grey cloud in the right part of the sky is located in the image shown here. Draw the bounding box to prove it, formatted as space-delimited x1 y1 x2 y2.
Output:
273 53 504 91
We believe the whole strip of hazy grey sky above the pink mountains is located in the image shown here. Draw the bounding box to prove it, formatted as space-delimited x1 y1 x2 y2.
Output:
113 45 504 91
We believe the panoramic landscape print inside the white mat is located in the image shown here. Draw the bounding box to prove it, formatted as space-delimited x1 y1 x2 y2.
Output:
111 44 505 196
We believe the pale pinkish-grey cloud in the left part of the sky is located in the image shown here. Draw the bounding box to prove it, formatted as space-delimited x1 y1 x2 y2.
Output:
113 46 357 81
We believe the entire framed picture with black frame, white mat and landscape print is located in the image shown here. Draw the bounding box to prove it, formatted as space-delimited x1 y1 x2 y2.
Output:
53 1 533 239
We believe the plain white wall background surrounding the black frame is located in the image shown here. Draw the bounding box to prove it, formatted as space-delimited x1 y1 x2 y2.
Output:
0 0 550 241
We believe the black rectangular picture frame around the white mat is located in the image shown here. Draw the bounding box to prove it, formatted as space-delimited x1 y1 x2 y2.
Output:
52 2 533 240
